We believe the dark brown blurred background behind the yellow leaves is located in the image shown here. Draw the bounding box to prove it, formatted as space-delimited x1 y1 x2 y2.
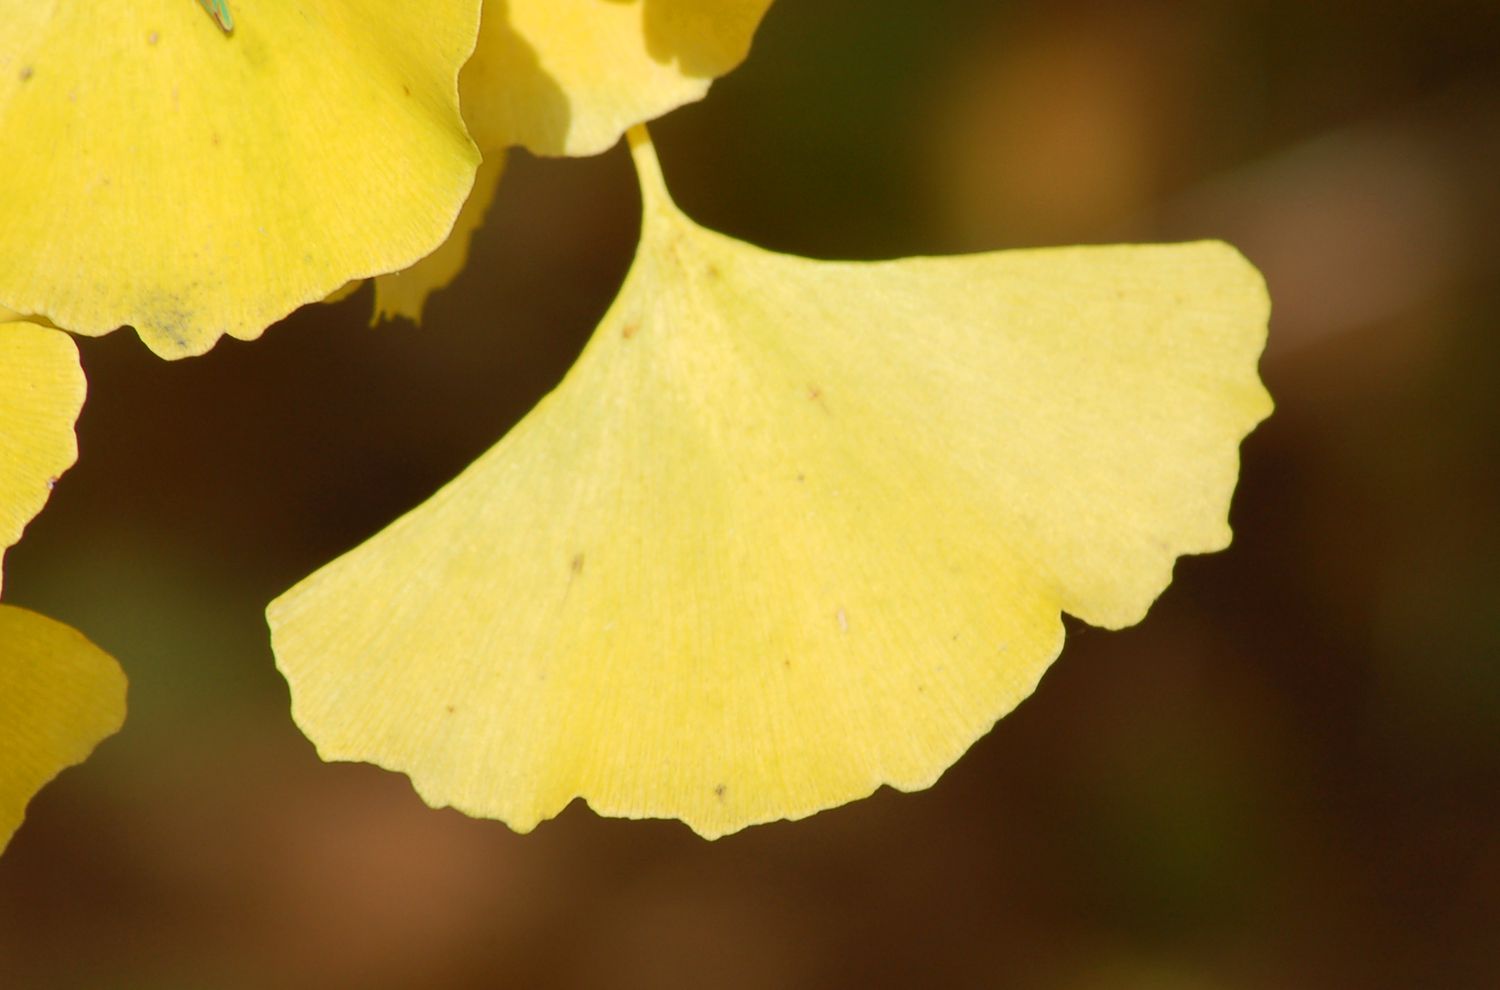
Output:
0 0 1500 990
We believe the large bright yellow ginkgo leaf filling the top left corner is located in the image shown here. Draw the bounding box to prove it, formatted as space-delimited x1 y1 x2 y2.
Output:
0 0 480 357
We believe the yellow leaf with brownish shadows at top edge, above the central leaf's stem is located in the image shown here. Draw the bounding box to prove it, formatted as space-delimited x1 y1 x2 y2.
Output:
464 0 771 155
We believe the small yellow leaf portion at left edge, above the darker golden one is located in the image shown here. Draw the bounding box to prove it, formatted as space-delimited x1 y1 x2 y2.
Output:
0 323 87 597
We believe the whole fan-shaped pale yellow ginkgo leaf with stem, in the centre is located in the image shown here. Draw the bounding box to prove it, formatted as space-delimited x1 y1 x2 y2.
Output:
269 123 1271 836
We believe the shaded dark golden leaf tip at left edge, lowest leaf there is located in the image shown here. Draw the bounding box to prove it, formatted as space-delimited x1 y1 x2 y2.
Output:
0 605 125 852
